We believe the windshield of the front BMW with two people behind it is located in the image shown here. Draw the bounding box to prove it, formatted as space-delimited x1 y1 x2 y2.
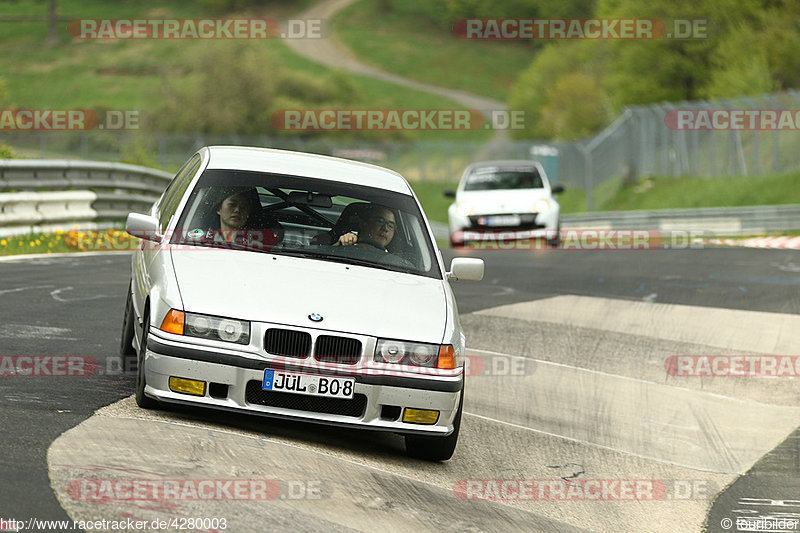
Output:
171 170 441 279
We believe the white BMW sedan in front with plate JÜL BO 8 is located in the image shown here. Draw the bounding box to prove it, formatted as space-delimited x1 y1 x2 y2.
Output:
121 146 483 460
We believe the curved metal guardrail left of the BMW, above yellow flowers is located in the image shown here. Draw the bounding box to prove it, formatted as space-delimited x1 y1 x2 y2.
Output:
0 159 172 235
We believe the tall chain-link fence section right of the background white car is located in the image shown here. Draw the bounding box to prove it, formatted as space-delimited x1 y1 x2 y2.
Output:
550 90 800 210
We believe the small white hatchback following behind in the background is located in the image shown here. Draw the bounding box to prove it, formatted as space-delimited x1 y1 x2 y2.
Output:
444 160 564 246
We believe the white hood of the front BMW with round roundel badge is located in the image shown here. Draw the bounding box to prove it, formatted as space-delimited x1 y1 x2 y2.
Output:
171 248 447 343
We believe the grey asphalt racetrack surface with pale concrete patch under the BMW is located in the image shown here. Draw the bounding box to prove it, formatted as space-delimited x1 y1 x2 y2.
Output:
0 248 800 532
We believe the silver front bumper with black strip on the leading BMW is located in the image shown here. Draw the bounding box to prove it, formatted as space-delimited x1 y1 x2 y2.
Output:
145 328 464 436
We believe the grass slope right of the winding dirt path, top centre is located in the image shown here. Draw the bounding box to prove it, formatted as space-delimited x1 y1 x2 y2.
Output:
333 0 534 101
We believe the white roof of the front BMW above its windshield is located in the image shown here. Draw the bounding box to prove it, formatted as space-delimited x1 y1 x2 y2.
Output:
200 146 411 195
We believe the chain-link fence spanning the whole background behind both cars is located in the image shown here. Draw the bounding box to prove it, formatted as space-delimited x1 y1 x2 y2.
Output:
0 91 800 210
